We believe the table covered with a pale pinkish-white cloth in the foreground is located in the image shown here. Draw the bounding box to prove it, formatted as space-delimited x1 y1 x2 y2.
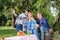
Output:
4 34 37 40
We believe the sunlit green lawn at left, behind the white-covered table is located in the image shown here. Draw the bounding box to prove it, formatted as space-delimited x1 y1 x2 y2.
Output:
0 27 16 38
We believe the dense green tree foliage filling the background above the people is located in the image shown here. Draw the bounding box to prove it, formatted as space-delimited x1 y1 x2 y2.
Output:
0 0 60 31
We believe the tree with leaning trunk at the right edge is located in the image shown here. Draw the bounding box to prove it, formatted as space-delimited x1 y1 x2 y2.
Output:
52 0 60 31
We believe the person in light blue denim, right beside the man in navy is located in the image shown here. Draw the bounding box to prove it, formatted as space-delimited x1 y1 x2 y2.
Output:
31 16 39 40
